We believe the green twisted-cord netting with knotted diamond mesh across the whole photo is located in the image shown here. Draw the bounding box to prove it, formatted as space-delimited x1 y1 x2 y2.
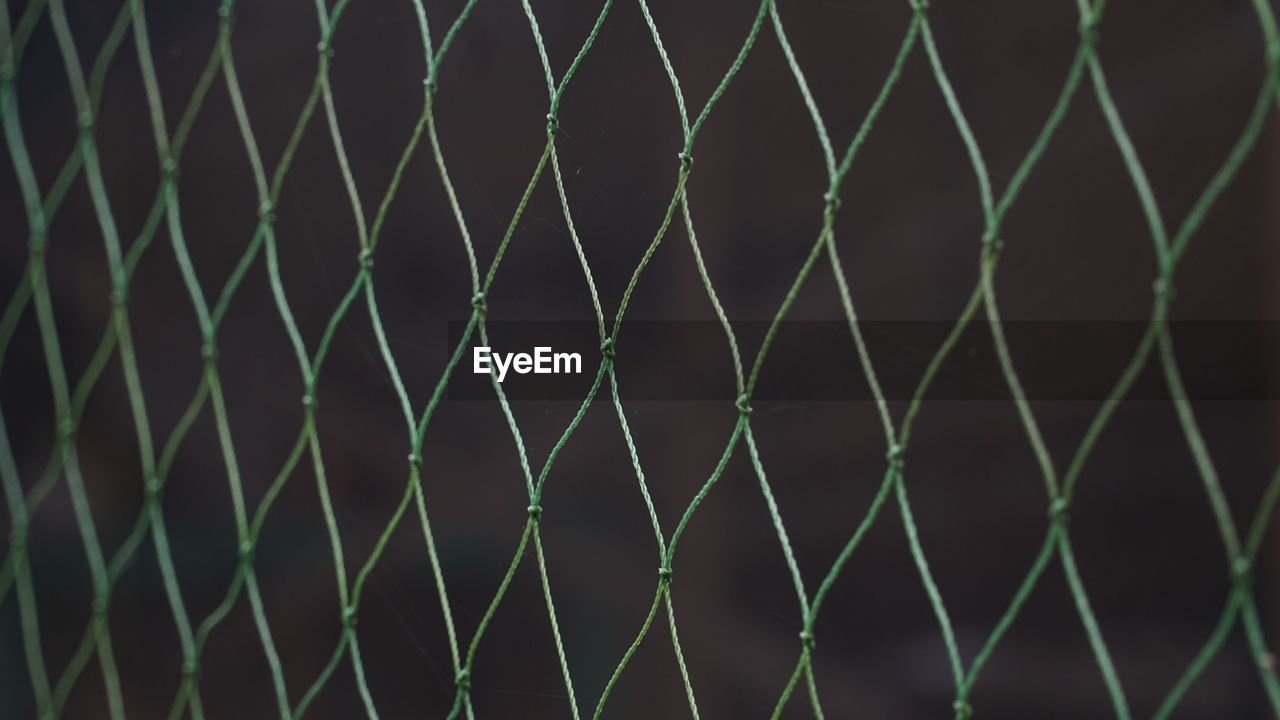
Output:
0 0 1280 720
